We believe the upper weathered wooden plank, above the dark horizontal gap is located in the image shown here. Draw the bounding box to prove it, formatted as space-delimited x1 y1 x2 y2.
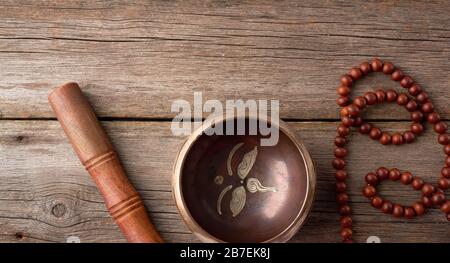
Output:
0 0 450 120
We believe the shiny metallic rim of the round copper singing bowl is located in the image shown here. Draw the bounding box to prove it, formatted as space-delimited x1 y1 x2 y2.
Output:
172 115 316 243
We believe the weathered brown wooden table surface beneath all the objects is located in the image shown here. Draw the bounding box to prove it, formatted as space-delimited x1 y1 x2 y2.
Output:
0 0 450 242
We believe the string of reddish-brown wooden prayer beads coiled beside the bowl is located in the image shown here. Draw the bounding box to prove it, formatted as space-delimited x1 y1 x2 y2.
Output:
332 58 450 243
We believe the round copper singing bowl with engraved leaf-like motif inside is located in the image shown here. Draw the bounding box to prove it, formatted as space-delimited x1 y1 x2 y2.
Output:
172 117 316 242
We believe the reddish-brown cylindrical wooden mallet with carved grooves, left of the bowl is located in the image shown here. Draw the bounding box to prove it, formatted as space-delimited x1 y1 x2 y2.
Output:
48 83 163 243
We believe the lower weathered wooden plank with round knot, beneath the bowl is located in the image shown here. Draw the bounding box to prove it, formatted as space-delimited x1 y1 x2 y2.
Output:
0 120 450 242
